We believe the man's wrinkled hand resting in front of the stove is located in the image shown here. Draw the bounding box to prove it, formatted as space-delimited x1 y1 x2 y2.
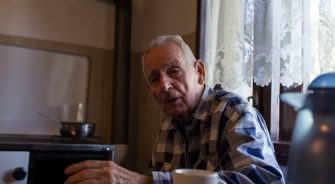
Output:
64 160 152 184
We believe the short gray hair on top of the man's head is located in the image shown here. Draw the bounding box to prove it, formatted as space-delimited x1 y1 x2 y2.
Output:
142 35 196 64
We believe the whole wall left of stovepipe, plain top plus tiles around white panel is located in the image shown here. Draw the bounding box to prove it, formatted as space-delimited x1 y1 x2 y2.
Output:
0 0 115 143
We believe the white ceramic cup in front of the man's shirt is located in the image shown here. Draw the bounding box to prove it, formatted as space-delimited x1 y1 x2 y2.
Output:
172 169 226 184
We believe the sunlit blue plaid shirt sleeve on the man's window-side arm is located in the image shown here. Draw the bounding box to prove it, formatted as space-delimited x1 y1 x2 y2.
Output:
218 104 285 184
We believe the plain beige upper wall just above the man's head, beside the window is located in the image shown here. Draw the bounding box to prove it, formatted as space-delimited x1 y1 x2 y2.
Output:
132 0 197 53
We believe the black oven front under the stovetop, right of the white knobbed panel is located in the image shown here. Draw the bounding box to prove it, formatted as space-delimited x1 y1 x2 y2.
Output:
28 151 112 184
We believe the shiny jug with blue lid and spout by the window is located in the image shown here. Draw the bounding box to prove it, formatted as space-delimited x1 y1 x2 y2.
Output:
280 72 335 184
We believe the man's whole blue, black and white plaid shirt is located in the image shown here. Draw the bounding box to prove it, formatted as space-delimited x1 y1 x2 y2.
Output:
151 85 284 184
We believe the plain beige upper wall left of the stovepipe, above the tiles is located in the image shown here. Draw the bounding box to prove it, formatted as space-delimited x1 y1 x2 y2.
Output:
0 0 115 49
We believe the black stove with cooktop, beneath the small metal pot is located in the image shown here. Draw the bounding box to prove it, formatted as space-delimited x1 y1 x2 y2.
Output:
0 134 114 184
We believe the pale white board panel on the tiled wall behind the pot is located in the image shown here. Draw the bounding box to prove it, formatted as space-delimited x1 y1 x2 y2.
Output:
0 45 89 135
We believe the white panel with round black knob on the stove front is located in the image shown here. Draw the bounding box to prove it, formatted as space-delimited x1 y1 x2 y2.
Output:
0 151 29 184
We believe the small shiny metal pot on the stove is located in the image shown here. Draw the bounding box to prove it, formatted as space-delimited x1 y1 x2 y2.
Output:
60 122 95 137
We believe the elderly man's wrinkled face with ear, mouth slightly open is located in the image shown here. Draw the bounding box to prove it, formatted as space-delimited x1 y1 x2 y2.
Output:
143 43 204 119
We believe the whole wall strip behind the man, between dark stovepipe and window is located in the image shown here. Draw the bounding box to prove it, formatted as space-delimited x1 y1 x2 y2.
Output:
125 0 197 173
